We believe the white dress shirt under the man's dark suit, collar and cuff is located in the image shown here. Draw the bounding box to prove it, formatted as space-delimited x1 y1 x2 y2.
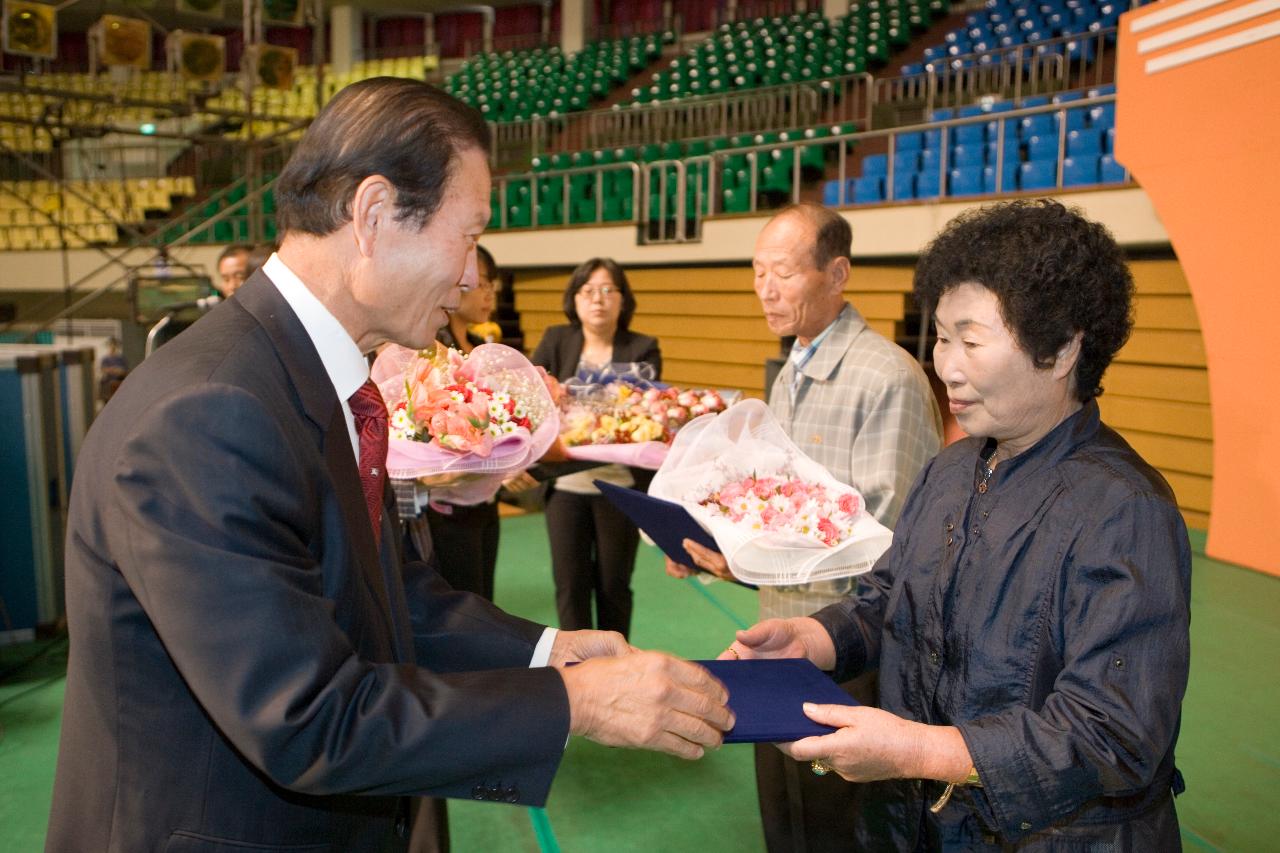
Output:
262 254 557 666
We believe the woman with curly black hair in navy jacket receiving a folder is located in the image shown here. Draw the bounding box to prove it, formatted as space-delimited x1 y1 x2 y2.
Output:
726 201 1190 852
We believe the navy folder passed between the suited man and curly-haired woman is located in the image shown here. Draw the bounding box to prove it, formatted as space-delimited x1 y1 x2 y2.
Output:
694 657 858 743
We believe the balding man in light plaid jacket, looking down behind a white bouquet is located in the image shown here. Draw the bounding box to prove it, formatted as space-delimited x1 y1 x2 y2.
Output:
667 204 942 853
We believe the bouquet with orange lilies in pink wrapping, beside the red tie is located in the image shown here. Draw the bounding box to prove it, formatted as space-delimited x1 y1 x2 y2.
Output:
371 343 559 505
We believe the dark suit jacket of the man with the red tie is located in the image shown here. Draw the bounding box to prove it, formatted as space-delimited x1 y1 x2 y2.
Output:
47 272 568 853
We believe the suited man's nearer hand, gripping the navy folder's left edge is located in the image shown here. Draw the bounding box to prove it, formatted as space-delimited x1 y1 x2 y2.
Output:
559 652 733 758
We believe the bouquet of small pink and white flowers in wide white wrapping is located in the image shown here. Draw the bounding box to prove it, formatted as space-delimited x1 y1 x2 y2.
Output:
649 400 892 585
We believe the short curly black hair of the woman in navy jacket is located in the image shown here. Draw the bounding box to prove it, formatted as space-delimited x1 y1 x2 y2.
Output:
914 199 1134 401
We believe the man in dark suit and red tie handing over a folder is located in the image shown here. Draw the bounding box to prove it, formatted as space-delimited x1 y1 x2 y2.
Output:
47 78 732 852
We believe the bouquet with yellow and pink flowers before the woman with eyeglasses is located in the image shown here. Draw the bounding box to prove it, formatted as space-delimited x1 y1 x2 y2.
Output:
561 361 726 469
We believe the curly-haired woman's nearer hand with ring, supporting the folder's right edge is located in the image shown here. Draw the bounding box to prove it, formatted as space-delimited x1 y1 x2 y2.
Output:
778 702 973 781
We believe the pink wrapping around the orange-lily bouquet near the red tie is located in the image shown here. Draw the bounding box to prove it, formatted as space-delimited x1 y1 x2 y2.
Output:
370 343 559 506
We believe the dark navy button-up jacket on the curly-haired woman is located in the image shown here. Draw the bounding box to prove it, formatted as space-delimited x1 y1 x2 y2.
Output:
815 402 1190 849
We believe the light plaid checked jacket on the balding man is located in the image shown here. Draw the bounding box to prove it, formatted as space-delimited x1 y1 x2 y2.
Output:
760 302 942 619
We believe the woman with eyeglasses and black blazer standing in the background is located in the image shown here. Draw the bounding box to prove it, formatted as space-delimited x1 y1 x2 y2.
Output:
531 257 662 637
